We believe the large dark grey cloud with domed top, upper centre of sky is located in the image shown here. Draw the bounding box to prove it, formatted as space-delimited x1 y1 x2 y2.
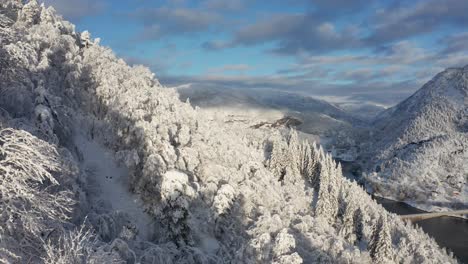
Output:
208 14 360 55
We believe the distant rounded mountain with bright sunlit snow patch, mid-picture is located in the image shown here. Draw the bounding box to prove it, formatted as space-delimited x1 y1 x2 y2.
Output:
178 87 365 136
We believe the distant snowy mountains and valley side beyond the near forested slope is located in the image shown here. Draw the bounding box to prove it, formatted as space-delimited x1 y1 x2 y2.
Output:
178 66 468 211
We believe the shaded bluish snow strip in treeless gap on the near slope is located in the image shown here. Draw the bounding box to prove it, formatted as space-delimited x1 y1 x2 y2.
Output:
75 133 153 240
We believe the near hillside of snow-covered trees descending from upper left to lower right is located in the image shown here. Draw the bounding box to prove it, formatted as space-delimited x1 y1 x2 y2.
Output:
0 0 457 264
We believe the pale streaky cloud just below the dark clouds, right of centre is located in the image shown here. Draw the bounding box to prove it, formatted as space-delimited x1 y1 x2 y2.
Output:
278 41 428 83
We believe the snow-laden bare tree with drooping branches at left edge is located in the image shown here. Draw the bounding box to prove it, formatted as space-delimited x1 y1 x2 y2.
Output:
0 128 74 258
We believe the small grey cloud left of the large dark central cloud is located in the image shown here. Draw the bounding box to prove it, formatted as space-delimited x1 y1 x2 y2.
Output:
130 7 222 40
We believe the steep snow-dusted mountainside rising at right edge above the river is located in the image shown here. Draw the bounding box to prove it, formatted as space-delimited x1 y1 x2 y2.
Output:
365 66 468 208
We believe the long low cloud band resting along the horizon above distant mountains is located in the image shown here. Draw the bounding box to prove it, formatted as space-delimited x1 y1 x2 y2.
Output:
160 71 422 106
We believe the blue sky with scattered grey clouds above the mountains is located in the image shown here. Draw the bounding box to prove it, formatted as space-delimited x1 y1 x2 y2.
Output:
45 0 468 106
